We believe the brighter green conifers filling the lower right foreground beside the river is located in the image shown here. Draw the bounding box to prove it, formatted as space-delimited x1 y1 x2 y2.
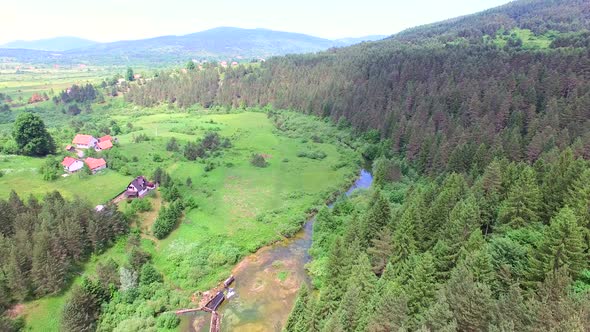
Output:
285 150 590 331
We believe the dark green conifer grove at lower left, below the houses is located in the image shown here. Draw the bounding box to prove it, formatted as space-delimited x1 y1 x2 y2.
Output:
0 191 129 330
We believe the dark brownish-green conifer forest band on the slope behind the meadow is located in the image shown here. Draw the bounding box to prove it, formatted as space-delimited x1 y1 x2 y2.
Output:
126 32 590 174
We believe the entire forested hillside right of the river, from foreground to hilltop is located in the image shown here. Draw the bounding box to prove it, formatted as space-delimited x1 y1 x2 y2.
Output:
126 0 590 331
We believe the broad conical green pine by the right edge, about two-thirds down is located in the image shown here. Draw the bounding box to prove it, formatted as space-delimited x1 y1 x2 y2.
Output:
533 207 588 280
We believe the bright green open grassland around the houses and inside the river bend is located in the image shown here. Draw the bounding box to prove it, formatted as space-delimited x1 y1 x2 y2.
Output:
17 107 358 331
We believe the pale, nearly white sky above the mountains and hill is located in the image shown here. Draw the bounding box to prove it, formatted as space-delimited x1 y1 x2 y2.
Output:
0 0 509 44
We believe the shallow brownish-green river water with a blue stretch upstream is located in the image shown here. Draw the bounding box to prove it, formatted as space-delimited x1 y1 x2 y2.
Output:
182 169 373 332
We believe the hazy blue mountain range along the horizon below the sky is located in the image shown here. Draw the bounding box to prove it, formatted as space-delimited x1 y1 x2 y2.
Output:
0 27 385 66
